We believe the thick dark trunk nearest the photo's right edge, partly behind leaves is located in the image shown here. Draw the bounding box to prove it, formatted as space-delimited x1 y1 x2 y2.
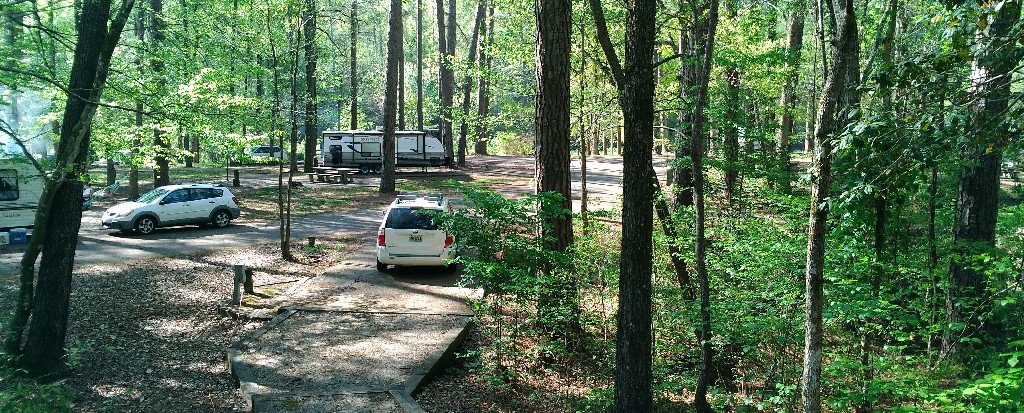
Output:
942 0 1021 356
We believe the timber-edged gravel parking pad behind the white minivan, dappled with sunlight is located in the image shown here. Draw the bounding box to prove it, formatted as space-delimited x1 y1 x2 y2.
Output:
227 238 481 413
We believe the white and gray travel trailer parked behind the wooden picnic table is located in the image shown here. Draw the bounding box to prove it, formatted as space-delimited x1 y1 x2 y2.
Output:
321 130 444 173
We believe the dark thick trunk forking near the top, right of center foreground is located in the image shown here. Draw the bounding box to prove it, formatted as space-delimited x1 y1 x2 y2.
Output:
589 0 657 413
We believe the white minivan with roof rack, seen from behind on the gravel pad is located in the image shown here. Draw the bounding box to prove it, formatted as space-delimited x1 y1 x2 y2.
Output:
377 194 455 272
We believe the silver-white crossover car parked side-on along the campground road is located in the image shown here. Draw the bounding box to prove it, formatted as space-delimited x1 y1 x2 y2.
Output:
100 183 242 235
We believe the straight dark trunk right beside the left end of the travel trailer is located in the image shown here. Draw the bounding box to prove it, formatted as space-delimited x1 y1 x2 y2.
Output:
301 0 319 172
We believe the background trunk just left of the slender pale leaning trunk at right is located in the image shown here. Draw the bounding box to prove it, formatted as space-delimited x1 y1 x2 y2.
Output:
775 1 807 194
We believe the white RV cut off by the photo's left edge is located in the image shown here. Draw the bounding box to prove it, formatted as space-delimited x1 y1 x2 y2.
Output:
0 158 45 232
